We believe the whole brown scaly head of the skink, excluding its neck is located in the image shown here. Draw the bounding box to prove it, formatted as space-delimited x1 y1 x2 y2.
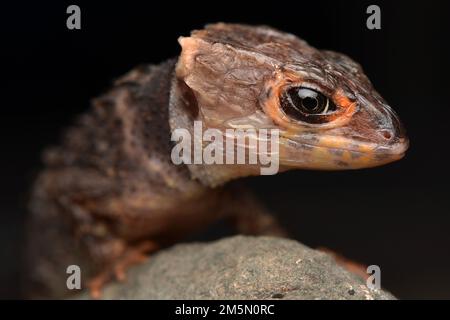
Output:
172 23 408 182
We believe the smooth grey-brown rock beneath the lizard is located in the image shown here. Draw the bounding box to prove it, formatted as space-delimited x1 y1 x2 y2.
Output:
84 236 395 299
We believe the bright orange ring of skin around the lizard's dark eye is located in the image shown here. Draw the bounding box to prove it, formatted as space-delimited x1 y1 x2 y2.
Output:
262 70 357 131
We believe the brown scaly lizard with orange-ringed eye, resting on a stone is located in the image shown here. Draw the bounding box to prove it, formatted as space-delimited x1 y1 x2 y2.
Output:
26 23 409 297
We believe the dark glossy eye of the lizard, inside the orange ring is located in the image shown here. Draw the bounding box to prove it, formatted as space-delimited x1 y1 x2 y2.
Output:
280 87 336 123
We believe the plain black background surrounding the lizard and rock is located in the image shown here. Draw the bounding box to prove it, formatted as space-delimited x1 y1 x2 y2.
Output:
0 0 450 298
